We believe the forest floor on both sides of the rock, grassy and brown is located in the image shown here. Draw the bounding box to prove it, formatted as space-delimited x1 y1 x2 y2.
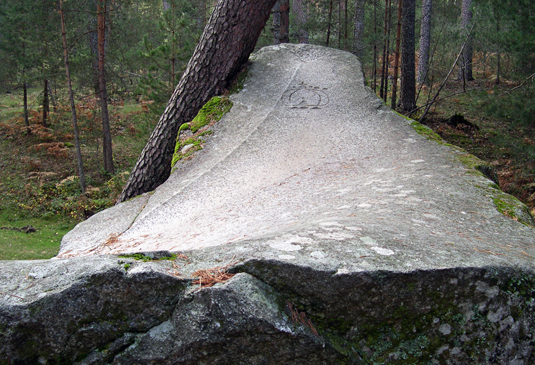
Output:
0 77 535 260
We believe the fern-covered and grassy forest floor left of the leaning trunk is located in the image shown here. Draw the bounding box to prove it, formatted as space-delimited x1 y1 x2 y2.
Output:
0 90 159 260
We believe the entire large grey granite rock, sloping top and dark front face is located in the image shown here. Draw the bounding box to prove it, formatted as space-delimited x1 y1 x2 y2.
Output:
0 45 535 365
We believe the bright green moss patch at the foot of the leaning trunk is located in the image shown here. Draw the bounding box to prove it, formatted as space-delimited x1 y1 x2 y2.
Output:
171 96 232 167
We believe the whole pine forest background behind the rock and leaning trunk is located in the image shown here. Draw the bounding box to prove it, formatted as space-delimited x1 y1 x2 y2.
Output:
0 0 535 259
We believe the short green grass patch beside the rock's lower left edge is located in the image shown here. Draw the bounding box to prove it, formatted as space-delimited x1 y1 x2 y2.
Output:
0 209 76 260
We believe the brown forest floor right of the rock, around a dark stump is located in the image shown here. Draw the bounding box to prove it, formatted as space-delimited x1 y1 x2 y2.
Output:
422 81 535 215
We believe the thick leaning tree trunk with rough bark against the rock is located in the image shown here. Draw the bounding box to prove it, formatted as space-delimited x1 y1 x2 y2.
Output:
118 0 276 202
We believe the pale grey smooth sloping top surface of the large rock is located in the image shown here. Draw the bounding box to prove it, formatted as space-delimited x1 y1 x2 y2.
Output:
58 45 535 271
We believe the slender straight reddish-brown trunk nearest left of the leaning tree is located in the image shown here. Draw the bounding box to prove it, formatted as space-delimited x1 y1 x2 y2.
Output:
97 0 115 174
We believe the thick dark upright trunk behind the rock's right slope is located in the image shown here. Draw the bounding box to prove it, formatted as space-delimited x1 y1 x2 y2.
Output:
399 0 416 112
